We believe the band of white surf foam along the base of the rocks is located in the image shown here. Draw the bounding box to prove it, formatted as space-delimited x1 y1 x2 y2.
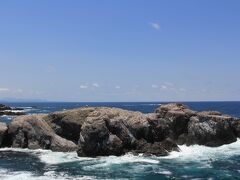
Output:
0 139 240 166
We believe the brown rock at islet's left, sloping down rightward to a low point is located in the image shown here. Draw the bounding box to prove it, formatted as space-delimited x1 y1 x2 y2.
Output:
6 115 77 152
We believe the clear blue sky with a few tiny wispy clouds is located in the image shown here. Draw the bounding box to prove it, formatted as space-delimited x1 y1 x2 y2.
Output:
0 0 240 102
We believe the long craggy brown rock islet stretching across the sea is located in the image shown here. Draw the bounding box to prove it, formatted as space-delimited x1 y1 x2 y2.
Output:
0 104 240 157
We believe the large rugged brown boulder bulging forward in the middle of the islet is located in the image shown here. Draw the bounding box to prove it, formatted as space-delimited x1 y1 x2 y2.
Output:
78 108 149 156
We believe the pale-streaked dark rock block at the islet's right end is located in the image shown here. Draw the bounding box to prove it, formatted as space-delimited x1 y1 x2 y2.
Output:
186 112 237 147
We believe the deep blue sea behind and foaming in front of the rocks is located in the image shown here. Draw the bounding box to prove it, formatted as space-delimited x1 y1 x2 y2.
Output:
0 102 240 180
